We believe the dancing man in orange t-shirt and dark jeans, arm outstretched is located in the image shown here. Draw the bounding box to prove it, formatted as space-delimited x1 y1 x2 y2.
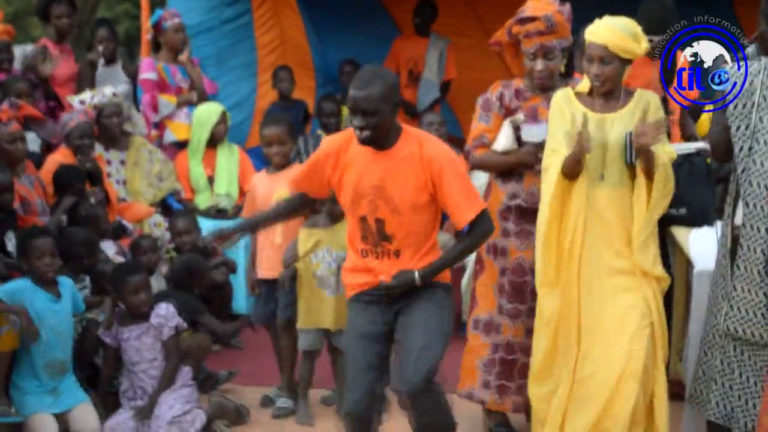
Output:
213 66 494 432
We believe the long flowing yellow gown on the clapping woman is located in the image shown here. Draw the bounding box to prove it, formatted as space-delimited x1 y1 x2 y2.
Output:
528 88 675 432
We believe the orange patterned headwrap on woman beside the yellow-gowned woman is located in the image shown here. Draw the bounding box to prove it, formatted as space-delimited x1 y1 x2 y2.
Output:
489 0 573 77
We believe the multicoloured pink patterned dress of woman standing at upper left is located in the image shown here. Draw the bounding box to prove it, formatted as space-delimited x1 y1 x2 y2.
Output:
136 57 218 155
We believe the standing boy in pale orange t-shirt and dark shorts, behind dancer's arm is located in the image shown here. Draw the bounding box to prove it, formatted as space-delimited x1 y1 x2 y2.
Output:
242 115 304 418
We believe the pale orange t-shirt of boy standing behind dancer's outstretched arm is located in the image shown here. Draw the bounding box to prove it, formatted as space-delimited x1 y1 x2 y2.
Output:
242 164 304 279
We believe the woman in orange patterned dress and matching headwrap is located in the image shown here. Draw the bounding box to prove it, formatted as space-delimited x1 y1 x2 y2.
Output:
458 0 572 432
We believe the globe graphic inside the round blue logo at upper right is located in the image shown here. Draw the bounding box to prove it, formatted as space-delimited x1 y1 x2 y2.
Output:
682 39 732 96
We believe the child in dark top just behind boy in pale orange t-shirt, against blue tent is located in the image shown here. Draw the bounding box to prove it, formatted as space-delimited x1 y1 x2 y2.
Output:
264 65 312 137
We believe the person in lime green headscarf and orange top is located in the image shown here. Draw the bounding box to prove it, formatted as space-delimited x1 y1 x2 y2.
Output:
174 102 255 217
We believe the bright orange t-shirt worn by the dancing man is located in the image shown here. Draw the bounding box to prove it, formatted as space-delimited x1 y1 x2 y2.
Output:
293 125 485 297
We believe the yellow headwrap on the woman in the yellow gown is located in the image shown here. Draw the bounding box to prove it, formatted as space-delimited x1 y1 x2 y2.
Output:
575 15 650 93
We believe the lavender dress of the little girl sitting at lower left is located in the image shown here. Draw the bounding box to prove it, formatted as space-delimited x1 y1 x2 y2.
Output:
99 303 206 432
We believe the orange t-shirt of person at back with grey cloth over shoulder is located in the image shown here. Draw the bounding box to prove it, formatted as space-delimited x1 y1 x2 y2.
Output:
384 34 458 124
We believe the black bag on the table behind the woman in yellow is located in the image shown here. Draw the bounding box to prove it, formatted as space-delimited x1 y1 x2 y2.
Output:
661 152 717 227
